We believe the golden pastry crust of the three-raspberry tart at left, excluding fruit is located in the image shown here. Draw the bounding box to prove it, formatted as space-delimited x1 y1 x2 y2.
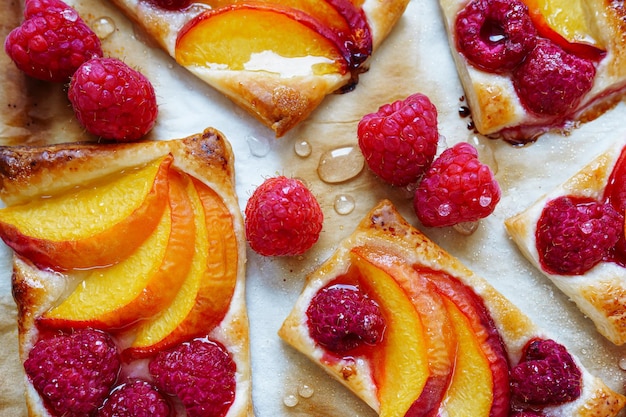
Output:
0 128 254 417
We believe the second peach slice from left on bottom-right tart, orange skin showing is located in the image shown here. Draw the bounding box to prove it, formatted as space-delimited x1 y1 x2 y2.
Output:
352 246 454 417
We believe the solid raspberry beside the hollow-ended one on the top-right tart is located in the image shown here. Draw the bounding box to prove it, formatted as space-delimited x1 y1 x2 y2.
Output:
513 39 596 116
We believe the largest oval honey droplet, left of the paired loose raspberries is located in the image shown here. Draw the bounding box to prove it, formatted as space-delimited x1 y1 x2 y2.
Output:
317 146 365 184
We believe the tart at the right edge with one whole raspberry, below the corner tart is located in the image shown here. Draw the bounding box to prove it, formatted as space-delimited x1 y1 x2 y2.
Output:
505 141 626 345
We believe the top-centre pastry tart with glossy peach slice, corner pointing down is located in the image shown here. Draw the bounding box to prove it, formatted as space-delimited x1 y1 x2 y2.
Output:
105 0 408 136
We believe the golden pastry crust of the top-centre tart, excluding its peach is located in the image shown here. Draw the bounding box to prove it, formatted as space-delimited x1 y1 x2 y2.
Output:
107 0 408 137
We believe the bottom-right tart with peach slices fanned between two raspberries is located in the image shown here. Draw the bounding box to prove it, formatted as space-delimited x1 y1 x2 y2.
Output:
279 200 626 417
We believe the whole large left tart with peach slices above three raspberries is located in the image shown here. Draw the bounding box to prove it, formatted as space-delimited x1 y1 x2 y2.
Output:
0 129 253 417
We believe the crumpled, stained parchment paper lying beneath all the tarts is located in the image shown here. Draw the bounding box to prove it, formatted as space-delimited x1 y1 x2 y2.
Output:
0 0 626 417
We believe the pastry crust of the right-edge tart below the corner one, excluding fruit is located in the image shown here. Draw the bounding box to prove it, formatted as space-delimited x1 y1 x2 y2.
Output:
505 144 626 345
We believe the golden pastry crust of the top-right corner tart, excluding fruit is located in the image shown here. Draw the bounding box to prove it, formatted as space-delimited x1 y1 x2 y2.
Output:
439 0 626 141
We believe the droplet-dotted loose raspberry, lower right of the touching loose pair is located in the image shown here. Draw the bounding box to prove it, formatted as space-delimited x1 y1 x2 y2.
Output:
414 142 500 227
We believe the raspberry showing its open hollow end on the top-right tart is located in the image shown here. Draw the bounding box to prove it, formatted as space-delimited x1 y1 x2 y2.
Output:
454 0 537 72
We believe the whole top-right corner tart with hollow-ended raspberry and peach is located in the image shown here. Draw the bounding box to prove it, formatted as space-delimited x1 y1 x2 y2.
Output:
439 0 626 143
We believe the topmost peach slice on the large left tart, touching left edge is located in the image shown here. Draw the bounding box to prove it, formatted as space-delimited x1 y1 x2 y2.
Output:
0 156 172 270
